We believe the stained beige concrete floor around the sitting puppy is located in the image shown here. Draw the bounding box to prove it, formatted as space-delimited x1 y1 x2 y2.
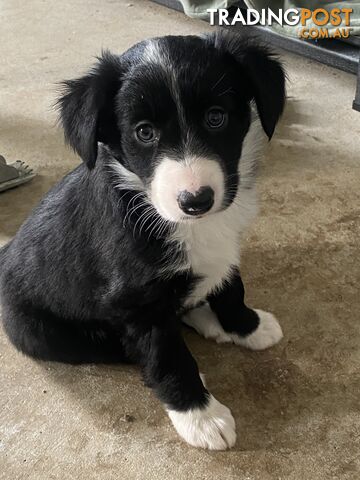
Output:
0 0 360 480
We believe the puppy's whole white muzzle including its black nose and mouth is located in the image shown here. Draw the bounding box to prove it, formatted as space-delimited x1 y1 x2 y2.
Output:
149 157 224 223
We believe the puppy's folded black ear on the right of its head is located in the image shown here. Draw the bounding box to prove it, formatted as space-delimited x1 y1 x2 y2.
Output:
214 32 286 139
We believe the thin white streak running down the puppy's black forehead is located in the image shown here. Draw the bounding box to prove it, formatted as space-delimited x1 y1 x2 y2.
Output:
143 39 185 127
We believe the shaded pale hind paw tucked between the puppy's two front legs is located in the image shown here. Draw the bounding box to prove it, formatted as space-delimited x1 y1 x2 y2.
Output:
182 304 233 343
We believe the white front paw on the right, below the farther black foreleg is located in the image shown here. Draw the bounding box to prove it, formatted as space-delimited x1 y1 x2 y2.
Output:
229 310 283 350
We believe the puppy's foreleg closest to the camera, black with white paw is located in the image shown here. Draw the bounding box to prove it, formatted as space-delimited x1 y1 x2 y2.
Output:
141 326 236 450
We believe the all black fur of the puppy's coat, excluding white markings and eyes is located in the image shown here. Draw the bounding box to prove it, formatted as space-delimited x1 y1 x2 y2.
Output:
0 33 285 410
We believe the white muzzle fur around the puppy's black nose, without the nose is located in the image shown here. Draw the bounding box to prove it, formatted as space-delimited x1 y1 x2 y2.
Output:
150 157 225 221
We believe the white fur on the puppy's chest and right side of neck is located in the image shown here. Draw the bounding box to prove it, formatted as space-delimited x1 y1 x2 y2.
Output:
172 119 265 306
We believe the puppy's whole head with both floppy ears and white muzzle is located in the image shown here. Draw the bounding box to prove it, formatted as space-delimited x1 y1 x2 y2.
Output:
59 32 285 222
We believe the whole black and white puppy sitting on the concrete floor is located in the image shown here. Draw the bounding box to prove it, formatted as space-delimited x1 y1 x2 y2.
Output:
0 32 285 449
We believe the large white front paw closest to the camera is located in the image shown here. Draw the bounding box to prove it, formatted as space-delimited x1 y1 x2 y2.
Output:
168 395 236 450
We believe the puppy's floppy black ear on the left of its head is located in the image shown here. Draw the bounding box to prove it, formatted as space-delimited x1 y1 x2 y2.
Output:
57 51 122 169
